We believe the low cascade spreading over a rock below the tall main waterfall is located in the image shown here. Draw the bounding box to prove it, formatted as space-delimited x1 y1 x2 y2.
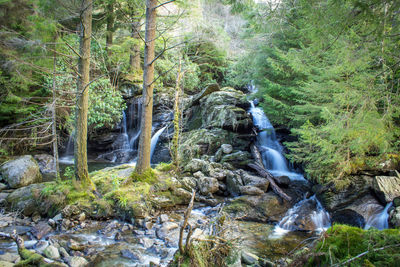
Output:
271 195 330 238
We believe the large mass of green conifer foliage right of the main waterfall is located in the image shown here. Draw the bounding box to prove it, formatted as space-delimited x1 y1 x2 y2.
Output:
228 0 400 186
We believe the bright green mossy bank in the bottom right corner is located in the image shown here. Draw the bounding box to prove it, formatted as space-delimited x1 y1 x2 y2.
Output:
307 225 400 266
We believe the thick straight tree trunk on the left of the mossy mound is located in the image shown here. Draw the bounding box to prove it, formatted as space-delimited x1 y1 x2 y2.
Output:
74 0 92 188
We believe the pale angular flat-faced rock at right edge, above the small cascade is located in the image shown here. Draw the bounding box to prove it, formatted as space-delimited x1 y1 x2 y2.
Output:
372 176 400 204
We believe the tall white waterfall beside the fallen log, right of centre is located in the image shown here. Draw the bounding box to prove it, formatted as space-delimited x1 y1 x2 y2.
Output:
250 101 305 180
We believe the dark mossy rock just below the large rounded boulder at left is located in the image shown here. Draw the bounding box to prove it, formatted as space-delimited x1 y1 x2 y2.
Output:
6 183 47 216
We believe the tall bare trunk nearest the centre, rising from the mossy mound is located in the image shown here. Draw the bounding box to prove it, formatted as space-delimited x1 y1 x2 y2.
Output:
136 0 157 173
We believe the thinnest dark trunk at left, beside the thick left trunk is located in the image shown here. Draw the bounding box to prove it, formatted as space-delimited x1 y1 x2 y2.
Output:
51 34 60 180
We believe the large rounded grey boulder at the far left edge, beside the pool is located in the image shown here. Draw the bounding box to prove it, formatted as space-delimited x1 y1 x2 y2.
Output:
0 155 42 188
